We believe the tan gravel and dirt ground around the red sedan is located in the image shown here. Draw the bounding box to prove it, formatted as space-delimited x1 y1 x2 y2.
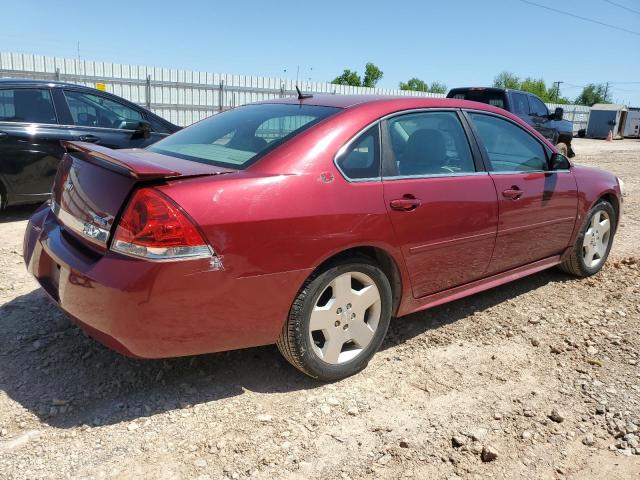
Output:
0 139 640 480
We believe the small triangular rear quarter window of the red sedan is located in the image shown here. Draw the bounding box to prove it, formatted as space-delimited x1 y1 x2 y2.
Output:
337 125 380 180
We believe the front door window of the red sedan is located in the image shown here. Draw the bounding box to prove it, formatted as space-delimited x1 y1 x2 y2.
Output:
470 113 548 172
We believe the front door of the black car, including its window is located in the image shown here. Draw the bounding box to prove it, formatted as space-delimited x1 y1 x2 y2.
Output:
59 89 167 149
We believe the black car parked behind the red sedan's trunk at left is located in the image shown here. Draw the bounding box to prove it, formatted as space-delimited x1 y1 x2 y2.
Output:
0 79 180 209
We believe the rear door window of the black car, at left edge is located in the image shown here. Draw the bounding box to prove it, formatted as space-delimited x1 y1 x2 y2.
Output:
0 88 57 123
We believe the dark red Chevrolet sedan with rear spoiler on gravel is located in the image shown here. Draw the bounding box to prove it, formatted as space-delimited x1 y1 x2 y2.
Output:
24 96 622 380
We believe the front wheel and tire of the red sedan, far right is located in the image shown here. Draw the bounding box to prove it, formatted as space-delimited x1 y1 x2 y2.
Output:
560 200 618 277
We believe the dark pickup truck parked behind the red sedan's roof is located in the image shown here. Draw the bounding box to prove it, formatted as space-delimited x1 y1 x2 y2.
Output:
447 87 575 158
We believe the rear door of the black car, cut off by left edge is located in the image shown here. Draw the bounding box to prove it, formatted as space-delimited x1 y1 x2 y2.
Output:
0 87 76 203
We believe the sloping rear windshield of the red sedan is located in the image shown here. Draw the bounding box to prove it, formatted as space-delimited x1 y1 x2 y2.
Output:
148 104 340 169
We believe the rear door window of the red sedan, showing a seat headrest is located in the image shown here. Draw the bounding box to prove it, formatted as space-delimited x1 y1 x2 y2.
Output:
385 112 475 177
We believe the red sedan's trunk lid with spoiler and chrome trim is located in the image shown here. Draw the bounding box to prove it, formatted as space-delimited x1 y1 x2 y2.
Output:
51 142 235 250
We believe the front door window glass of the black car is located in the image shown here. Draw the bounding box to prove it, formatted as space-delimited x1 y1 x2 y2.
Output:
64 90 143 130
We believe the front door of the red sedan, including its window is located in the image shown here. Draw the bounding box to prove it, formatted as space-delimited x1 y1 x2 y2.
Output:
468 112 578 273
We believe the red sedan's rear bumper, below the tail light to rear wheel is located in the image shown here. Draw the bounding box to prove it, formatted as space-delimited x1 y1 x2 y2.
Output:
24 206 310 358
